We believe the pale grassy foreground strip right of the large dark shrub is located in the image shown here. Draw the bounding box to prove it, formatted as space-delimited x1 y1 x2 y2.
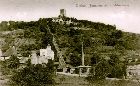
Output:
56 75 140 86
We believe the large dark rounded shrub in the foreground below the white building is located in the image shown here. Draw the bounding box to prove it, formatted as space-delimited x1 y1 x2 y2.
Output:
11 60 55 86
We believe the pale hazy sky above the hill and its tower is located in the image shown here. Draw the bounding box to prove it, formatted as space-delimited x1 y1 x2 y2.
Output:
0 0 140 33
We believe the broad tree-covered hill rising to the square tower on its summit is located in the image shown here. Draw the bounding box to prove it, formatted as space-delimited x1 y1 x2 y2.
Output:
0 17 140 61
